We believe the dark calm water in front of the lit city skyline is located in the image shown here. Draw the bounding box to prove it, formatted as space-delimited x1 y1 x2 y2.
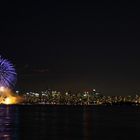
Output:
0 105 140 140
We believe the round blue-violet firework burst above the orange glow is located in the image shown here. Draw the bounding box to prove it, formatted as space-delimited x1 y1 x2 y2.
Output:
0 56 17 88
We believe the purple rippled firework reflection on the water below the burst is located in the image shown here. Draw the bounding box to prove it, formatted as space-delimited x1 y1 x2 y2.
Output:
0 106 18 140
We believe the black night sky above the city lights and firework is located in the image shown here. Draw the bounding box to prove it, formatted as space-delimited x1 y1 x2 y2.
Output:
0 0 140 95
